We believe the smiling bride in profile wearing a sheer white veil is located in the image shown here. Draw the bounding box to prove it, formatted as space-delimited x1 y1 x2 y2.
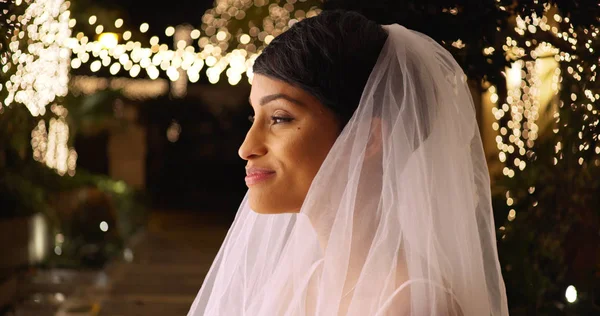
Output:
188 11 508 316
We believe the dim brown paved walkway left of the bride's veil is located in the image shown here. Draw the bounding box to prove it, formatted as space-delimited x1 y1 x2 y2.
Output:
14 212 232 316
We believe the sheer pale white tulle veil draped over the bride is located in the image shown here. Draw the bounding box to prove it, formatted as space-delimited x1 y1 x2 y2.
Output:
188 25 508 316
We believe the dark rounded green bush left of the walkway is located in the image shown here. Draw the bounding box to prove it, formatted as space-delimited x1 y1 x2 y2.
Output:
40 171 146 268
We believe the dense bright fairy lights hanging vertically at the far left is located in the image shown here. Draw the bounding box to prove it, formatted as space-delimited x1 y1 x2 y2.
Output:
0 0 77 175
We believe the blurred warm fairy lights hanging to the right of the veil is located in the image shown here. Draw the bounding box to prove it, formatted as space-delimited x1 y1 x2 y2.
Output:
484 7 600 262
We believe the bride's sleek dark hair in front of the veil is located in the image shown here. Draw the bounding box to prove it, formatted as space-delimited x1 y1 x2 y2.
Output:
253 10 388 126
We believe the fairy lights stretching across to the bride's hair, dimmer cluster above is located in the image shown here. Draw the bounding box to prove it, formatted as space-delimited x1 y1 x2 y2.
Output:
66 0 320 85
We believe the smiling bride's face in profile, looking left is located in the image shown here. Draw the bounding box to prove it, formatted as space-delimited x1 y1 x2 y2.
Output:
239 74 341 214
